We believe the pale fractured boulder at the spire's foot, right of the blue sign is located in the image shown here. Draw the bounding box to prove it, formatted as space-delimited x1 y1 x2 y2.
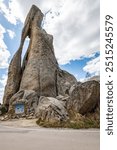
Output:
36 97 69 122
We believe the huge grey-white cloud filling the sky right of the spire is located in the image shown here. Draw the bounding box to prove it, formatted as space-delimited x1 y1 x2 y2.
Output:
40 0 100 64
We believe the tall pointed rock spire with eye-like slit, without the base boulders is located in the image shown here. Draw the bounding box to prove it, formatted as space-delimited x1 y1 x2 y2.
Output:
3 5 76 105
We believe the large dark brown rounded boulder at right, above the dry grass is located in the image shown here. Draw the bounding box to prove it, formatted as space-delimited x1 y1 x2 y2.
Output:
70 81 100 114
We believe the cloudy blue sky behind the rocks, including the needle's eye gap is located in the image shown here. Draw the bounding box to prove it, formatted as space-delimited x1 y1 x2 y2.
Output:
0 0 100 101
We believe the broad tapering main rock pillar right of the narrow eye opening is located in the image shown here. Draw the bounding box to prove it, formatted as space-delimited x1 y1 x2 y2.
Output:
20 7 58 96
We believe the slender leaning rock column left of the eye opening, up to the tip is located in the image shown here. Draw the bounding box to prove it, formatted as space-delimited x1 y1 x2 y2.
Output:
3 5 42 105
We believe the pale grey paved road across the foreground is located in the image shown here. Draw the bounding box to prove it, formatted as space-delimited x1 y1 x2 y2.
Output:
0 125 100 150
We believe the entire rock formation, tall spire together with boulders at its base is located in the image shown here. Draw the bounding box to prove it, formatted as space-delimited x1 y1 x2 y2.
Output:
0 5 100 125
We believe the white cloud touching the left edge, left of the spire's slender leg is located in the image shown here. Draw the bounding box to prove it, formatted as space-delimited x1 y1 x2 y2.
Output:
0 24 10 69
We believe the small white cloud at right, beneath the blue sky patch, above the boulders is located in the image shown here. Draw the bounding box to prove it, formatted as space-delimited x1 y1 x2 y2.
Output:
83 56 100 75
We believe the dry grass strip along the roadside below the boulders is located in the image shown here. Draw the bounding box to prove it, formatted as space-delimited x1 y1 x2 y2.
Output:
36 112 100 129
